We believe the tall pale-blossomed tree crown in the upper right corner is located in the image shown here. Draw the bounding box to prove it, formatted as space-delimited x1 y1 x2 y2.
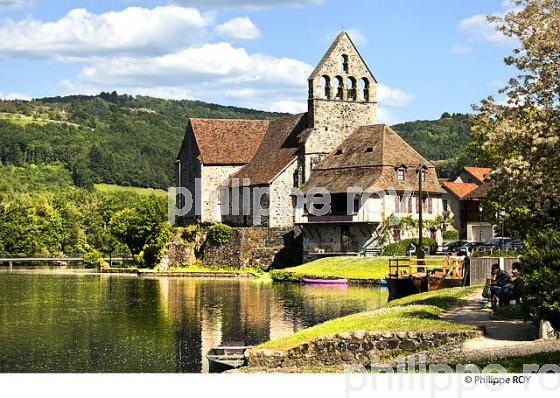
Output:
472 0 560 209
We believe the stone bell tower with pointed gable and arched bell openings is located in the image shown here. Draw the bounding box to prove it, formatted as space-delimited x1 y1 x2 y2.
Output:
303 31 377 181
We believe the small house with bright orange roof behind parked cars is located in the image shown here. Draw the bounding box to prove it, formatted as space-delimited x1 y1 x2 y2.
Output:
441 166 494 241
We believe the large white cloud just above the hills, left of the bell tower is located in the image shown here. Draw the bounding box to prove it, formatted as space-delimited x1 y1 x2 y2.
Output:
60 42 312 112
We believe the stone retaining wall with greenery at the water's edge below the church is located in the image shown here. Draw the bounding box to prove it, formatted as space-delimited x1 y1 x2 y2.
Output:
203 227 302 270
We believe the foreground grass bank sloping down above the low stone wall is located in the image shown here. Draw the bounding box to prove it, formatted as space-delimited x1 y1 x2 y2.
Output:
257 287 479 350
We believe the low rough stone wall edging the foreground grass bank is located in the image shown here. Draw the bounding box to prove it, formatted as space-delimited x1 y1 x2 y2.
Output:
245 331 483 369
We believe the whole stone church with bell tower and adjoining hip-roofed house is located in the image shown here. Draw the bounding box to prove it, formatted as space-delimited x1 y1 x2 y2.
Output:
177 32 445 262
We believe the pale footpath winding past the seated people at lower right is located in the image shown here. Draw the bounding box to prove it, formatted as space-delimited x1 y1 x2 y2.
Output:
443 289 560 361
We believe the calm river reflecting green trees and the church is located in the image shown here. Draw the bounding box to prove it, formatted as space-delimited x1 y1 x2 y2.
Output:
0 268 387 373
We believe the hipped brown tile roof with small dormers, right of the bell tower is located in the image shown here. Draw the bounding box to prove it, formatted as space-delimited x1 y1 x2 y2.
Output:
302 124 444 193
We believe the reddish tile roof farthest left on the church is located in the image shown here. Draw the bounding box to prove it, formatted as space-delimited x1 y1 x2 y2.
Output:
187 118 270 165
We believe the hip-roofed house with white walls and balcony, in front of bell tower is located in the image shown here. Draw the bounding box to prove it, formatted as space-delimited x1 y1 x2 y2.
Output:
296 124 444 258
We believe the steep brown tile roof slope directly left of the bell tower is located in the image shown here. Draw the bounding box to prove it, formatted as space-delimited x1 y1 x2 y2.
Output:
231 113 310 185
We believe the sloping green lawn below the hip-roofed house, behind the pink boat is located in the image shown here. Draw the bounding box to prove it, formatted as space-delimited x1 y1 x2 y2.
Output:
271 257 389 281
